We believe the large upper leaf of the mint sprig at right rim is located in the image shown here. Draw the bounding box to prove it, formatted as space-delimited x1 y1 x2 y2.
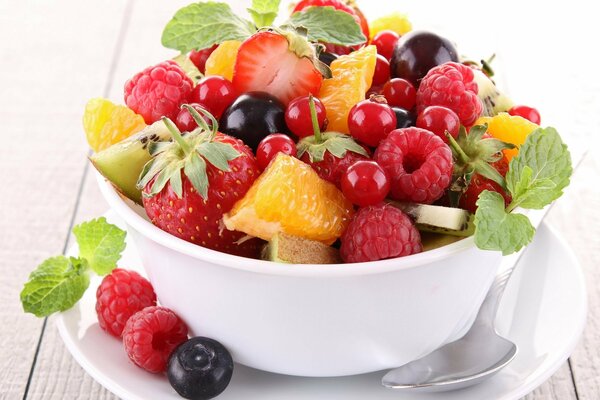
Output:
506 128 573 209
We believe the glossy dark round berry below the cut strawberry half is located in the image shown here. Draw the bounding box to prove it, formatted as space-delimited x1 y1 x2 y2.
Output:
219 92 287 151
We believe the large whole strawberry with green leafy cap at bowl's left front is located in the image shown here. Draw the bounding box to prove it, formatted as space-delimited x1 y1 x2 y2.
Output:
138 105 261 257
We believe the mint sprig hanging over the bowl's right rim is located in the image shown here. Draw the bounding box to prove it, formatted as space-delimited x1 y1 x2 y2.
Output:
474 128 573 255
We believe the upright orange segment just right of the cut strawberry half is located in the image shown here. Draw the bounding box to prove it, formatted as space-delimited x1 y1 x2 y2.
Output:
319 46 377 133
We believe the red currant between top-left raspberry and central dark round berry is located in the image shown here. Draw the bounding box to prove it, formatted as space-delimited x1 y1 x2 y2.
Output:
191 75 238 119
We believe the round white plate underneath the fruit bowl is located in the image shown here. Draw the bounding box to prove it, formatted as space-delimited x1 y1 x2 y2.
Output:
56 213 587 400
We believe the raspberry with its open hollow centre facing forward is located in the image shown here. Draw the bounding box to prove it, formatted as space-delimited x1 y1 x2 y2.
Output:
374 128 453 204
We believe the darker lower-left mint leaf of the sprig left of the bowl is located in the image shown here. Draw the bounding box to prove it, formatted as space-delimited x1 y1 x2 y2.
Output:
21 256 90 317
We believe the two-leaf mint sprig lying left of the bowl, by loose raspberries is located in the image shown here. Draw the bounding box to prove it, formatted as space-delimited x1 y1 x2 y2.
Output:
20 217 125 317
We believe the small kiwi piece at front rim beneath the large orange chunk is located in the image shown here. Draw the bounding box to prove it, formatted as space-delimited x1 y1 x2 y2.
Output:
262 232 342 264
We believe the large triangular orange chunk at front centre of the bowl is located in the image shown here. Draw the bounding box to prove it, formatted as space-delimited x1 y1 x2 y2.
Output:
223 153 354 245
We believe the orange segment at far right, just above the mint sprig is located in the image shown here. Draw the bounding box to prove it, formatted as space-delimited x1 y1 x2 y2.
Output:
475 113 539 161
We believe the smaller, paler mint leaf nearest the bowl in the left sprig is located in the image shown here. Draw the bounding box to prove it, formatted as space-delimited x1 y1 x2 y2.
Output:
73 217 126 275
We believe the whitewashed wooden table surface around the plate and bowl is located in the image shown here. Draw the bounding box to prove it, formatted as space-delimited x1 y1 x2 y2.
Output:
0 0 600 400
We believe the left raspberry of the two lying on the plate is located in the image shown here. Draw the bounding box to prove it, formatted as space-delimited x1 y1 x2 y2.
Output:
96 268 156 337
